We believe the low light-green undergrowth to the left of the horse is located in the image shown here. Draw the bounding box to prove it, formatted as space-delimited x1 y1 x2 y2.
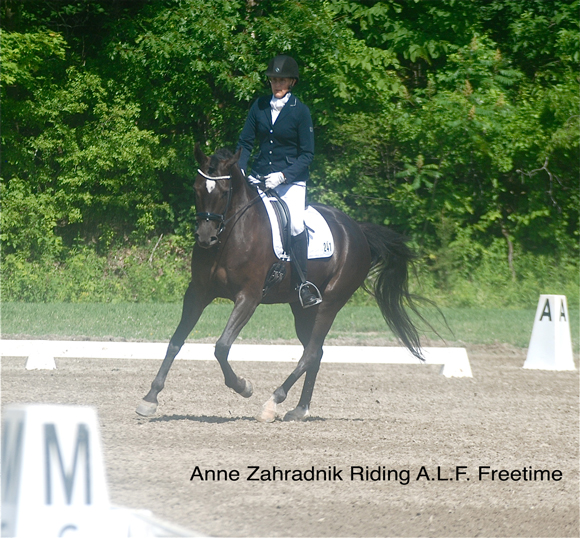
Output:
0 237 190 303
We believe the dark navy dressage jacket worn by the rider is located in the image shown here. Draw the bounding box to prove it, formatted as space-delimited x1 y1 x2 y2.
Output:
236 95 314 183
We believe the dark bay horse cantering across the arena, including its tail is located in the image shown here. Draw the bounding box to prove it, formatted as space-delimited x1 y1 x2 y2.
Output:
137 145 422 422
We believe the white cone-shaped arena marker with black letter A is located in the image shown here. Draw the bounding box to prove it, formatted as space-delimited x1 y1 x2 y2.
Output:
524 295 576 370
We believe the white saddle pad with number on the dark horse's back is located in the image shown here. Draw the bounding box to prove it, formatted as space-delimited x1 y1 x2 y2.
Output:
258 189 334 261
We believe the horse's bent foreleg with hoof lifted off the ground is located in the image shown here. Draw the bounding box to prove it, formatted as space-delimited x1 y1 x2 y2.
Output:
215 295 260 398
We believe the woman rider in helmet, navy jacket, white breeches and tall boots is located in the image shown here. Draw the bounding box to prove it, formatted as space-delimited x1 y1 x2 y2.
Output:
238 55 322 308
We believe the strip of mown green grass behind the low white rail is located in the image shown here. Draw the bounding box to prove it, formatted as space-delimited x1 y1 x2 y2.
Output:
1 303 579 351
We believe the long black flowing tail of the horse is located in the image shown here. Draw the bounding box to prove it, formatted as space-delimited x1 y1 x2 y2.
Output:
360 223 425 360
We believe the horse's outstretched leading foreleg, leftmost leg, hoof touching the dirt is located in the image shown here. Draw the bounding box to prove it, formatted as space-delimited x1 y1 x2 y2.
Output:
136 284 209 417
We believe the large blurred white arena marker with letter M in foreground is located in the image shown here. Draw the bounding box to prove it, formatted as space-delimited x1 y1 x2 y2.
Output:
2 404 117 537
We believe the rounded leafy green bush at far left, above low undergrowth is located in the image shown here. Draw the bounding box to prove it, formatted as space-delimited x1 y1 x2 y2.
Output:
2 62 173 255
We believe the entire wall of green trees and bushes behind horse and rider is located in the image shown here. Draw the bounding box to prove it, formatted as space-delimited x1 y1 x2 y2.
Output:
0 0 580 305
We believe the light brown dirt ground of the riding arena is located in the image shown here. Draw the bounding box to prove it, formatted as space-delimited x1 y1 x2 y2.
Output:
2 346 579 537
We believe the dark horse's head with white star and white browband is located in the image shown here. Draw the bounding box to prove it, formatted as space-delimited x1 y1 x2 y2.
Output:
194 143 241 248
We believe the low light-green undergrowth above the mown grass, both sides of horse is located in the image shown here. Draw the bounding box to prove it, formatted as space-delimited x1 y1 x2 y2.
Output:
0 230 580 309
